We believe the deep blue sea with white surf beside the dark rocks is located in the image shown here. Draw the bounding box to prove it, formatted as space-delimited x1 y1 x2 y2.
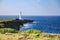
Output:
0 16 60 34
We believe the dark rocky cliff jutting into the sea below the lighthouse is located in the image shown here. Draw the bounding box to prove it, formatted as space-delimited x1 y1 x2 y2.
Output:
0 19 33 30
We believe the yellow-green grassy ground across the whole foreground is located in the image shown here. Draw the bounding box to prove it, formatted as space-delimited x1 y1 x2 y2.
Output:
0 28 60 40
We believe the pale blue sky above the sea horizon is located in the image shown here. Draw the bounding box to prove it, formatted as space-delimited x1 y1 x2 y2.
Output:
0 0 60 16
